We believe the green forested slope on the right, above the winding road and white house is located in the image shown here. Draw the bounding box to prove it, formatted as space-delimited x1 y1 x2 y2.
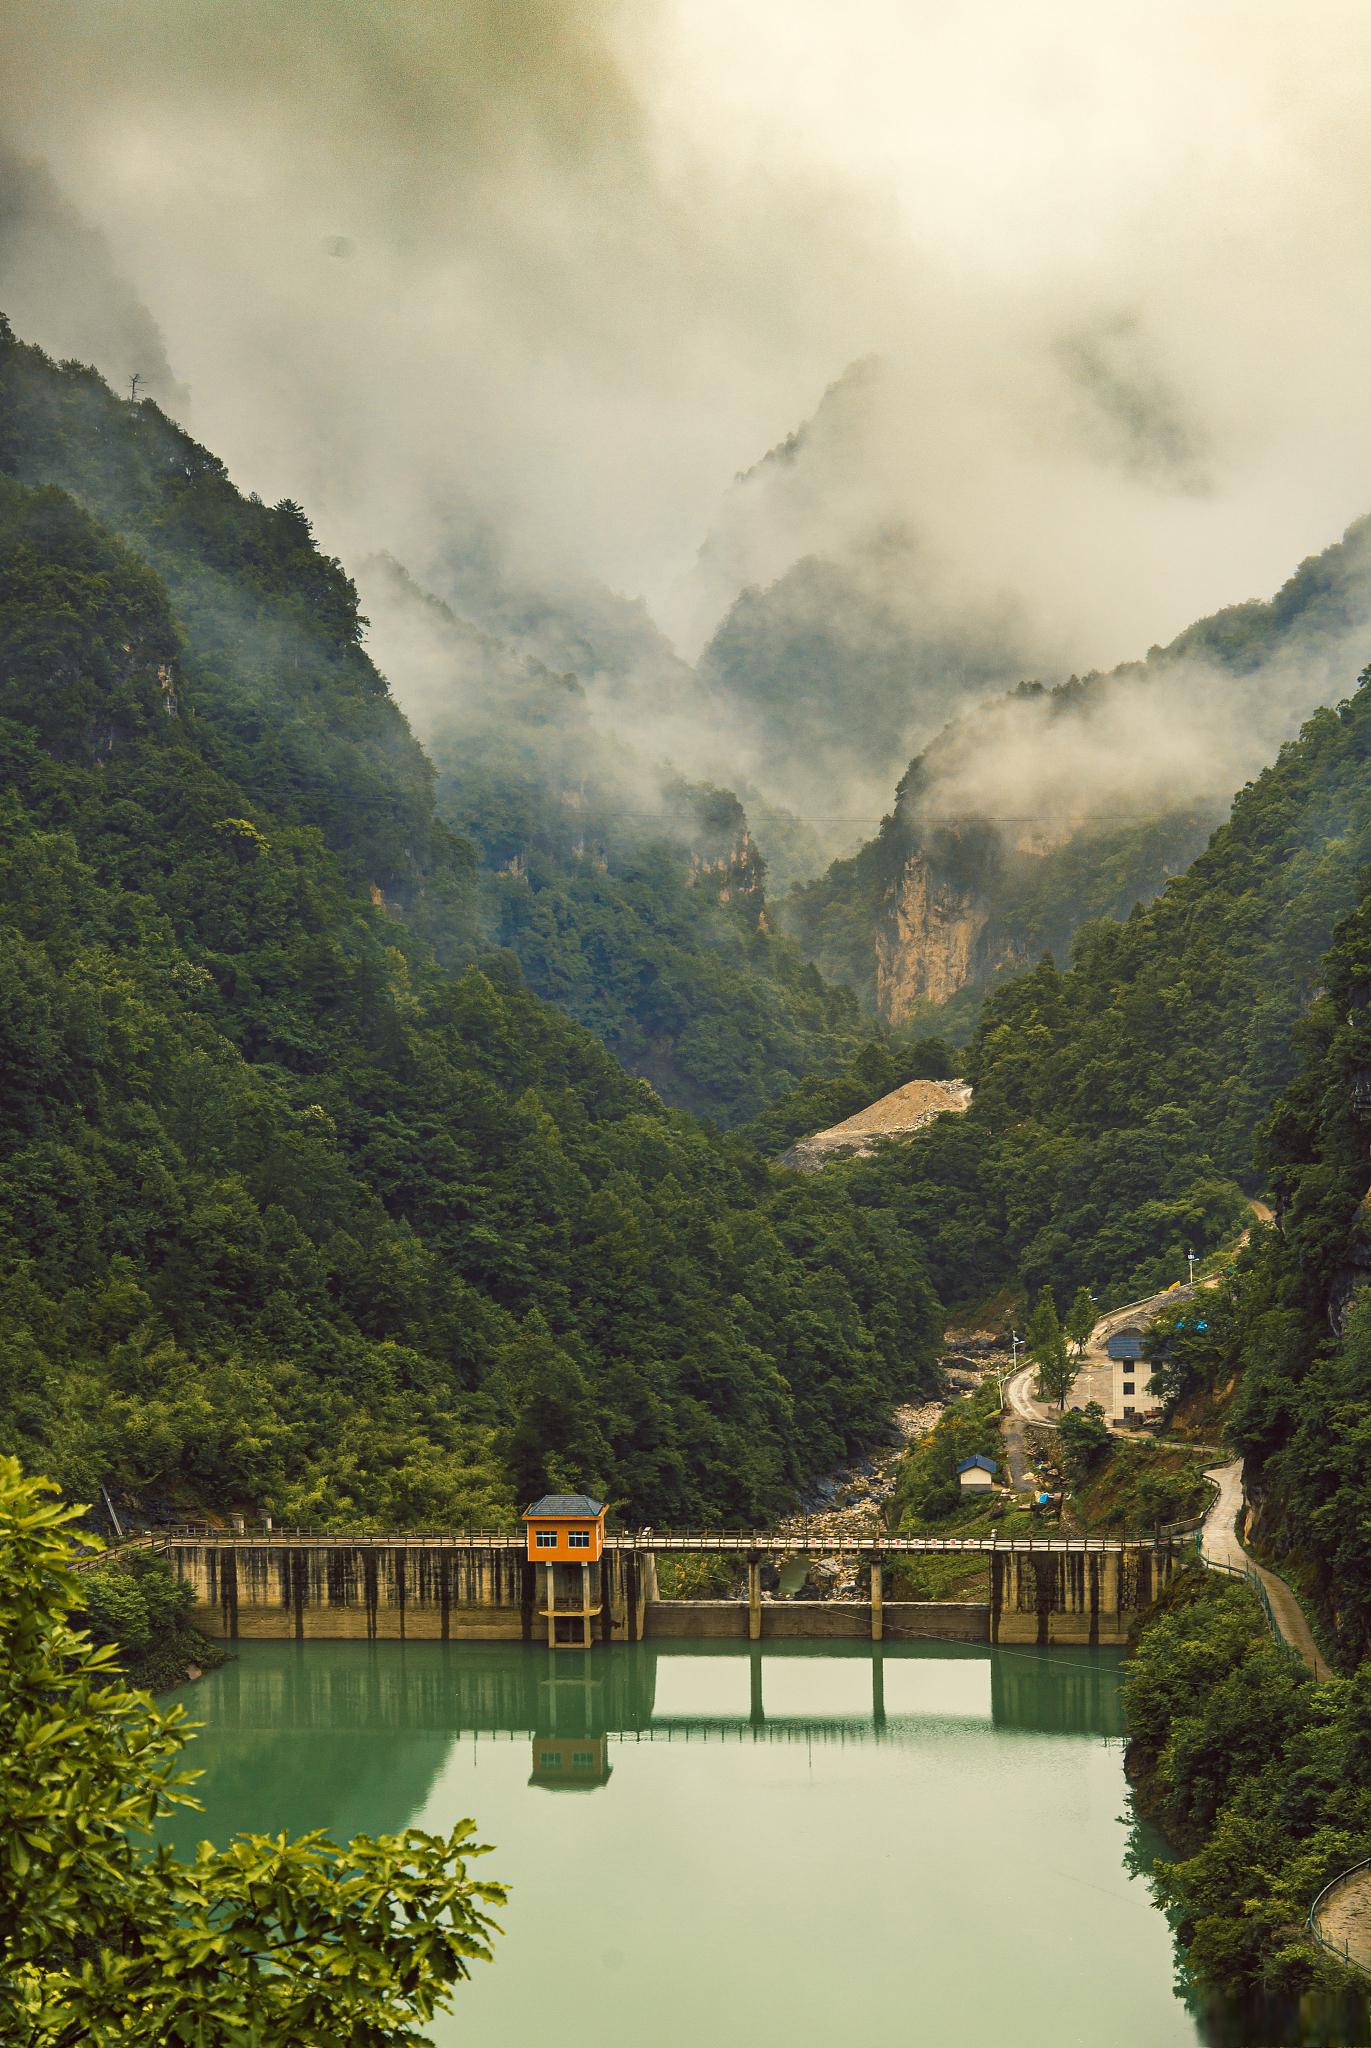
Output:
827 682 1371 1300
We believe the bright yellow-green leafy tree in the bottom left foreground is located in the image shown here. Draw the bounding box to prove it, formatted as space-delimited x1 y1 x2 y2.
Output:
0 1458 504 2048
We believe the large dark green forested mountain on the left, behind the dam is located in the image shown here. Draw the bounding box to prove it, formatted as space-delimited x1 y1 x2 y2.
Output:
0 330 937 1524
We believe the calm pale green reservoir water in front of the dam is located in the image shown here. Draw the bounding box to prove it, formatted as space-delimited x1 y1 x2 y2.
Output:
166 1640 1205 2048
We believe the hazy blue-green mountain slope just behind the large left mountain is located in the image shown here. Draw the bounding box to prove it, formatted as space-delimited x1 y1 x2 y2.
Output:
367 563 873 1124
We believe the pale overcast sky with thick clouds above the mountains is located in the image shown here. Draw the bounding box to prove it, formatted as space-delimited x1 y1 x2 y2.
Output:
0 0 1371 668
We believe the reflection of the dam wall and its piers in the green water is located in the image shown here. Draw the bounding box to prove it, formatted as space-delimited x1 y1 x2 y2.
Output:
179 1640 1123 1790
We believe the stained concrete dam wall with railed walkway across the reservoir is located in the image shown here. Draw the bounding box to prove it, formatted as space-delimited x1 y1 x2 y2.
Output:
143 1528 1189 1649
